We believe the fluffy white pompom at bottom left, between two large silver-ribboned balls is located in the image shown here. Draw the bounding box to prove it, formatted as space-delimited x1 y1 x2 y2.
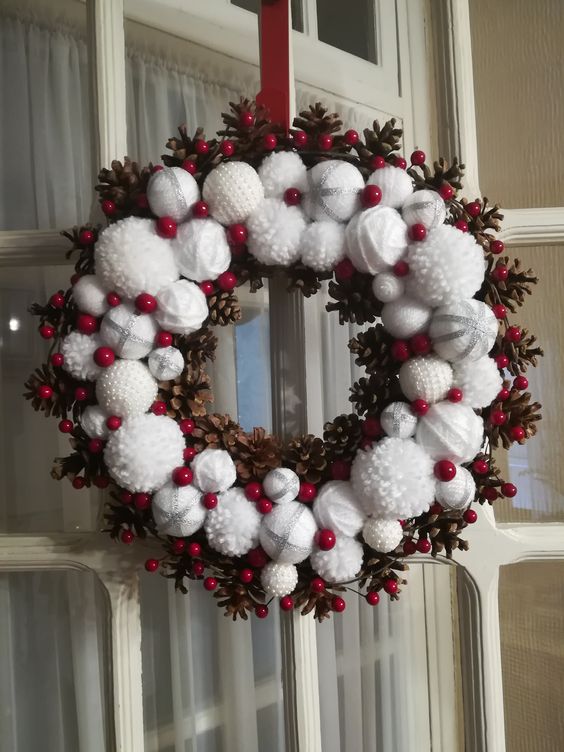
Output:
204 488 261 556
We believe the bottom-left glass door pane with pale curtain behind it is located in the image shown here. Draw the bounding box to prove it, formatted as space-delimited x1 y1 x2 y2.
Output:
0 571 115 752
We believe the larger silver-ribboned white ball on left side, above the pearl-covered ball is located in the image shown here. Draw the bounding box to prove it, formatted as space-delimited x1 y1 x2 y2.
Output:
100 303 159 360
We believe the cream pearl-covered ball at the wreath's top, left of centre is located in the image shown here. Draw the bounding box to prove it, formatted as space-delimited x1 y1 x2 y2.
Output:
202 162 264 225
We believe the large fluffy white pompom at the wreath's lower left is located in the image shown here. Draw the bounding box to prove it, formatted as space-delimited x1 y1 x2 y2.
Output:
104 412 186 493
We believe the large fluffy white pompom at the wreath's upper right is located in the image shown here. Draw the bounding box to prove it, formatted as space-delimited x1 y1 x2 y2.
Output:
406 225 486 307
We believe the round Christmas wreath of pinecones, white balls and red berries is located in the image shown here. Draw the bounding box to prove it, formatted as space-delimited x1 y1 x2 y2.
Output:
25 100 542 620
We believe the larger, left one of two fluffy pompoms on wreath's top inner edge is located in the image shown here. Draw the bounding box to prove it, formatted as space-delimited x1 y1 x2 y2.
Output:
247 198 306 266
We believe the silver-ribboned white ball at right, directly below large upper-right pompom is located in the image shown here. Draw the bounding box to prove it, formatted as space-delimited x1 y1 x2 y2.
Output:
429 300 499 361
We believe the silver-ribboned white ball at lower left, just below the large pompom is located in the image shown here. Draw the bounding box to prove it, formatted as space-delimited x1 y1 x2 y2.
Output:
151 481 207 538
